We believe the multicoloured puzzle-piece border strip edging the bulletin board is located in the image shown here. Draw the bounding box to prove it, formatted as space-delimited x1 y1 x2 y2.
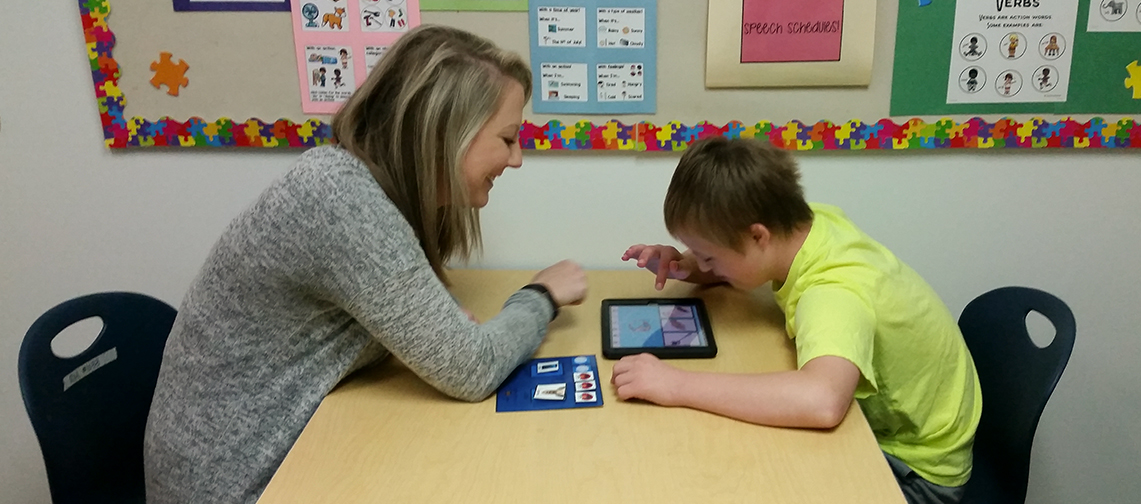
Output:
78 0 1141 152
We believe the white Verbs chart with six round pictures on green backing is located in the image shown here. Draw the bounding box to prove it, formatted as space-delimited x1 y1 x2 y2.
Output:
944 0 1077 104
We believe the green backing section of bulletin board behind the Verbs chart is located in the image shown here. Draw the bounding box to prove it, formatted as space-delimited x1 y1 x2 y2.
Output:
891 0 1141 116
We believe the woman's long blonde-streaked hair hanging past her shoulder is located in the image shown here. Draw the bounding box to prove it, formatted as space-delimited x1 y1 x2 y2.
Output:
332 25 531 282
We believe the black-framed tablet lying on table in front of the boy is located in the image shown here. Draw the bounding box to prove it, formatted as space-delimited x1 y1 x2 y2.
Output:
602 298 717 359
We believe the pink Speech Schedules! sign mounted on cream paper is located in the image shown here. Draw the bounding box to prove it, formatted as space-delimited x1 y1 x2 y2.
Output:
741 0 844 63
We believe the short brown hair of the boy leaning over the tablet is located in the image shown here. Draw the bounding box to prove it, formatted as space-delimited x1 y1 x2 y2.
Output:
664 137 812 251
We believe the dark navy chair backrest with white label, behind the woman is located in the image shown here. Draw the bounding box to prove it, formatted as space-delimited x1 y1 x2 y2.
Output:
19 292 176 504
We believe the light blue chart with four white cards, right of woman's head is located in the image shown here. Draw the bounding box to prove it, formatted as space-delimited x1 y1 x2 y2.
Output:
529 0 657 114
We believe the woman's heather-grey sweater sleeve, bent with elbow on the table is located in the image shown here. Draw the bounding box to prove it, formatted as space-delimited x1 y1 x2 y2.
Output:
285 163 552 400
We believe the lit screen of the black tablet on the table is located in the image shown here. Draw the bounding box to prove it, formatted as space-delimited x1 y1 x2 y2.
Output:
610 303 709 348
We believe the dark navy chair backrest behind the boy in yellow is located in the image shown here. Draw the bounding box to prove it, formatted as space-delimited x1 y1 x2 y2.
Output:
958 287 1076 504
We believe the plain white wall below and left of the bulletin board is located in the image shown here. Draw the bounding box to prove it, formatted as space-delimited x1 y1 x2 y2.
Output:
0 1 1141 504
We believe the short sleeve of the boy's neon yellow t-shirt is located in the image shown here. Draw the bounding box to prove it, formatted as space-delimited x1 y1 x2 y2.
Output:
794 285 879 398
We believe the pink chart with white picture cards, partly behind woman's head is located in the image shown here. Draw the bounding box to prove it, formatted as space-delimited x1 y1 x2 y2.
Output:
291 0 420 114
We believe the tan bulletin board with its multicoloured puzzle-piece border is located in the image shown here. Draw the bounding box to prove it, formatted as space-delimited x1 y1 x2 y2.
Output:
78 0 1141 152
